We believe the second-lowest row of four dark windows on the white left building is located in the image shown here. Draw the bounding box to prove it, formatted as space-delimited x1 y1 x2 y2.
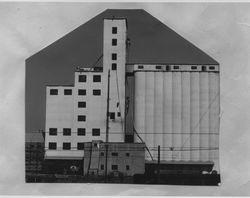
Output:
49 128 101 136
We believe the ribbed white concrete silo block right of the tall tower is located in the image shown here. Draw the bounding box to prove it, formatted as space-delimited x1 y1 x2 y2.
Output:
134 65 220 170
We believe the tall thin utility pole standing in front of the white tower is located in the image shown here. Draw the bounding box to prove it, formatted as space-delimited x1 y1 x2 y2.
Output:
105 69 110 182
